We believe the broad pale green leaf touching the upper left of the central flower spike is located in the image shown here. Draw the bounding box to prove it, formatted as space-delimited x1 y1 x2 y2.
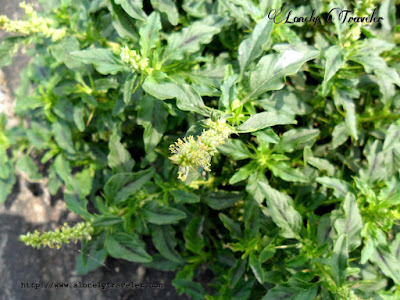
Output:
143 72 208 115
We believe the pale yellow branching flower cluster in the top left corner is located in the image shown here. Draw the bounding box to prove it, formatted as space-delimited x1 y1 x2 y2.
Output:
0 2 66 41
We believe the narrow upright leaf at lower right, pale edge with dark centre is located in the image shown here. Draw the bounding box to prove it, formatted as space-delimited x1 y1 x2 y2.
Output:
331 234 349 286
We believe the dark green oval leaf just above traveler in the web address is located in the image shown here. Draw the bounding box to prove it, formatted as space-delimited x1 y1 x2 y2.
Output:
105 233 152 263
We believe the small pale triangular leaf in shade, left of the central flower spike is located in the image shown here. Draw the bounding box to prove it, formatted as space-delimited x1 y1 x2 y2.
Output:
107 132 135 173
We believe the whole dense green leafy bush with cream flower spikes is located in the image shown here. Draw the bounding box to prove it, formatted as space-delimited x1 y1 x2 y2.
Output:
0 0 400 300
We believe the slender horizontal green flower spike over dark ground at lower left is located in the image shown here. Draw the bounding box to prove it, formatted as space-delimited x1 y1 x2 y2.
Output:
20 222 93 249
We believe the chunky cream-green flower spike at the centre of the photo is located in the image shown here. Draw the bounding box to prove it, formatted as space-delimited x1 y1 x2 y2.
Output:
169 119 233 181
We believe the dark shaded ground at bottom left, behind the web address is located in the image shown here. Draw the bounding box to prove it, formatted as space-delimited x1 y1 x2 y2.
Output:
0 214 188 300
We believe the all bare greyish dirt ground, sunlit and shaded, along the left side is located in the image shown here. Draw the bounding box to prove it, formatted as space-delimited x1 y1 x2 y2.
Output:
0 0 188 300
